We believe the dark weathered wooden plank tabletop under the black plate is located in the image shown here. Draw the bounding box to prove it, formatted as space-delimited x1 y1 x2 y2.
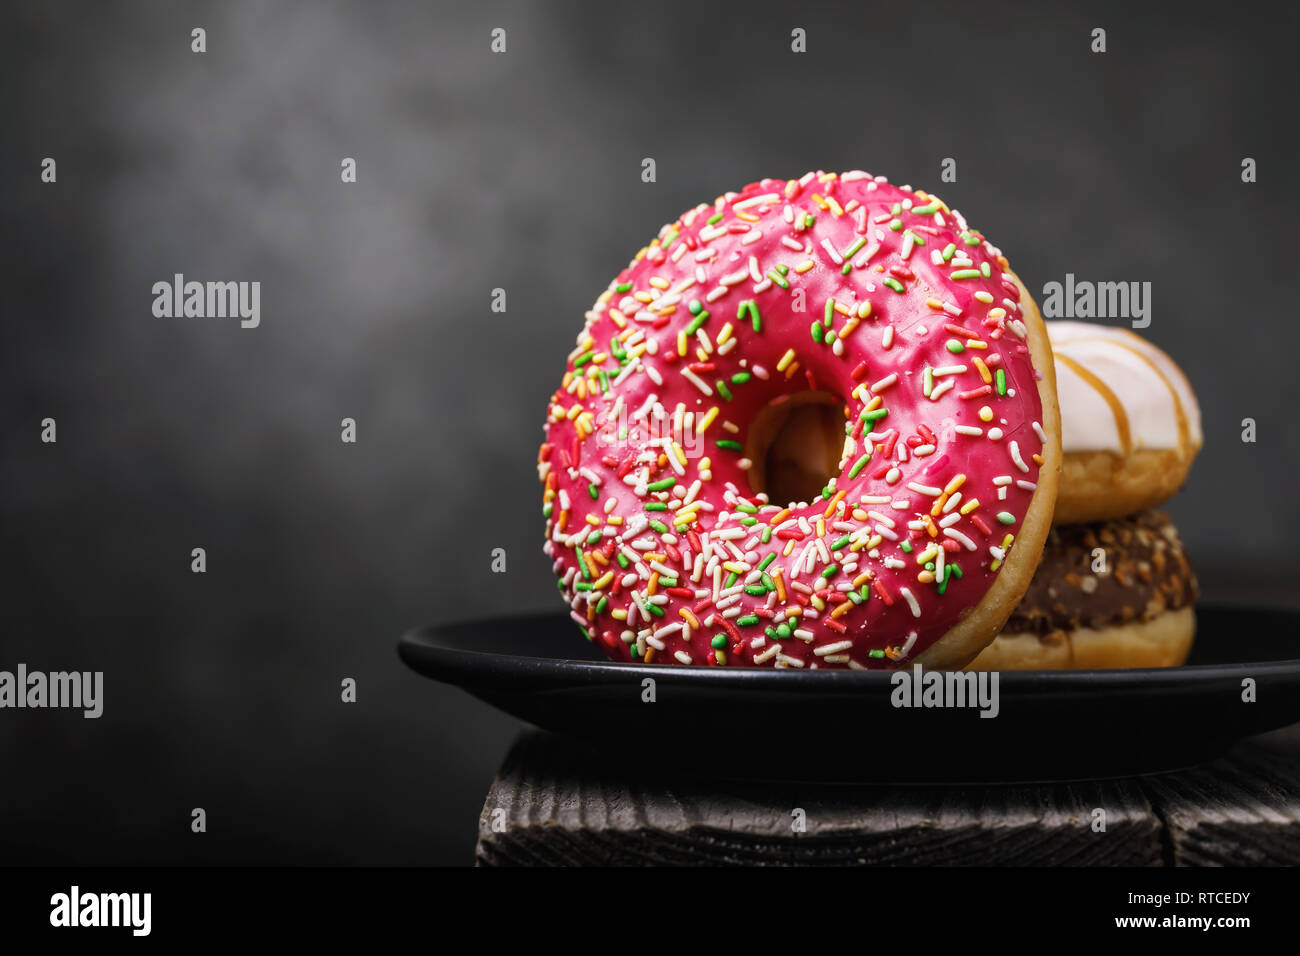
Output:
476 724 1300 866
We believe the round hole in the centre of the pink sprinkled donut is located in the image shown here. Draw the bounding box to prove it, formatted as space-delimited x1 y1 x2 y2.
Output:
746 392 848 506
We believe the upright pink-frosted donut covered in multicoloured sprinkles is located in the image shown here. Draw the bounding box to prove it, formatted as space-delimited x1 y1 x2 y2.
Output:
538 172 1061 669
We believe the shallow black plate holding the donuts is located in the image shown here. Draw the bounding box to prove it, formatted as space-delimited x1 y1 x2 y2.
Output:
399 607 1300 783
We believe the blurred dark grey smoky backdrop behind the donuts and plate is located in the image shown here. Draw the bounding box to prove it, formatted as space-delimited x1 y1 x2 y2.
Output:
0 1 1300 862
